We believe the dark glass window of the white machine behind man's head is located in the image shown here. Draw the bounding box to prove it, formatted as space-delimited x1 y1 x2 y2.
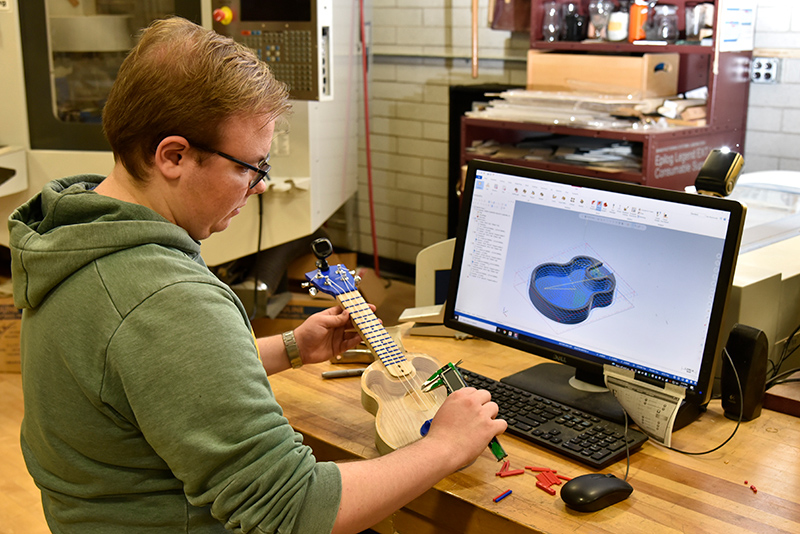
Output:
46 0 176 123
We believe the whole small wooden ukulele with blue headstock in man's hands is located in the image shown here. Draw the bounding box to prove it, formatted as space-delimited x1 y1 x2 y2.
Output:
306 255 447 454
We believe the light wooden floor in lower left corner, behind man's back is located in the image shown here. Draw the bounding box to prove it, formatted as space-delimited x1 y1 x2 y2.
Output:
0 373 50 534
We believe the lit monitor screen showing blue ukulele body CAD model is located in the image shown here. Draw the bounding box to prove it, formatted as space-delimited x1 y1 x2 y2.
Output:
454 169 730 389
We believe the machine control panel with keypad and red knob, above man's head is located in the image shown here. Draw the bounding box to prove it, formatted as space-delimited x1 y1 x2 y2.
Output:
212 0 333 100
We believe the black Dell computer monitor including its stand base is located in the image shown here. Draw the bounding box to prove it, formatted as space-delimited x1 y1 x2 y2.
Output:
444 160 745 428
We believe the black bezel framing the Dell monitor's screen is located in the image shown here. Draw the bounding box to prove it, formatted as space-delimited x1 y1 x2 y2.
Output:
444 159 746 404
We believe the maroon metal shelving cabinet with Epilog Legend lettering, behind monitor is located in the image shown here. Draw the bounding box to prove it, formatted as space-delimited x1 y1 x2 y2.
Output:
461 0 752 193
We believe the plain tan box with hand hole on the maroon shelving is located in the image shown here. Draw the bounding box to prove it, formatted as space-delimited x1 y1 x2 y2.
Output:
527 50 680 99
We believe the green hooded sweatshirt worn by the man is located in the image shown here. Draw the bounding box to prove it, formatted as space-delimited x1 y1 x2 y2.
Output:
9 175 341 534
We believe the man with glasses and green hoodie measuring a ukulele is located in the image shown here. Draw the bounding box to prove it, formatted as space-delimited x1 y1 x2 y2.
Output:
9 14 506 534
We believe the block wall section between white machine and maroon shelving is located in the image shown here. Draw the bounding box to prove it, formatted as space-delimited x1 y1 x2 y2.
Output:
356 0 529 263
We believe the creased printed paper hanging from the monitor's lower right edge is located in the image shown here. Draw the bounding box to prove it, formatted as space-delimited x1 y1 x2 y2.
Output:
604 365 686 447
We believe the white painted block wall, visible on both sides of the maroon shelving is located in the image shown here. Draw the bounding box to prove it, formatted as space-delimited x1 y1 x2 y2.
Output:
357 0 800 263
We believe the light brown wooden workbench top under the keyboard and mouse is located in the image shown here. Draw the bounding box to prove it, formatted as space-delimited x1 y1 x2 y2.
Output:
270 328 800 534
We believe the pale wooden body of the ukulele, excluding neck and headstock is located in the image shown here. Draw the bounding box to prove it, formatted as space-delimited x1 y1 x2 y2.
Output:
361 354 447 454
